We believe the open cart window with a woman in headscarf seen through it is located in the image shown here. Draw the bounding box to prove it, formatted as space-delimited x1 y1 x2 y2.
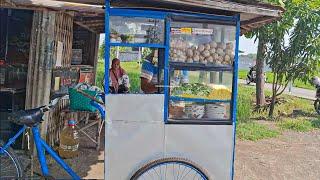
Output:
109 46 164 94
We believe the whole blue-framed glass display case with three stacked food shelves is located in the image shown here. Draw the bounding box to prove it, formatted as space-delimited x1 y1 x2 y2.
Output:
168 18 236 124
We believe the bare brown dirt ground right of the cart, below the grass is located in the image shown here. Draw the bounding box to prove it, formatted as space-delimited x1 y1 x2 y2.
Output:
234 126 320 180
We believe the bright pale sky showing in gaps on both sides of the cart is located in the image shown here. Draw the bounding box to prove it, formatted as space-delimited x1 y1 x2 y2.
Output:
100 34 258 54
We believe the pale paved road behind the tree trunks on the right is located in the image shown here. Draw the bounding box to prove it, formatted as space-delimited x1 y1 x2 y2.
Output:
238 79 316 100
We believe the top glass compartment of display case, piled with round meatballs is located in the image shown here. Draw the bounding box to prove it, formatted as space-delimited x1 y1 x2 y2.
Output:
170 22 236 65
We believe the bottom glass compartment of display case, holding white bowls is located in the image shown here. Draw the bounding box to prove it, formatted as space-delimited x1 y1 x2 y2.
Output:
169 101 230 121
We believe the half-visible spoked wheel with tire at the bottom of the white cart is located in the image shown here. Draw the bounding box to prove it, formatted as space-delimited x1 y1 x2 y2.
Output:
130 157 209 180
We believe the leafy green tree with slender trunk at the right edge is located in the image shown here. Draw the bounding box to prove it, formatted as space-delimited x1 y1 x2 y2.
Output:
265 0 320 117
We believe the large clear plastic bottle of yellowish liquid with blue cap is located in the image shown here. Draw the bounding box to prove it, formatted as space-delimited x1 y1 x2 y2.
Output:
59 120 79 158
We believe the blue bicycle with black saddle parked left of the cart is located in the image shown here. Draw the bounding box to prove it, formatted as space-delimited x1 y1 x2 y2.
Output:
0 90 105 180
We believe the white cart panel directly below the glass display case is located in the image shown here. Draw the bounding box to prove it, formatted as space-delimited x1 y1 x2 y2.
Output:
165 125 233 180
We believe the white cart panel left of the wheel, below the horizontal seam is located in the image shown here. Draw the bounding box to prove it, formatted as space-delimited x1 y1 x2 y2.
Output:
105 121 164 180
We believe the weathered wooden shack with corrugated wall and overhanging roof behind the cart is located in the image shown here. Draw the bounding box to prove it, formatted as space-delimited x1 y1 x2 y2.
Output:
0 0 284 148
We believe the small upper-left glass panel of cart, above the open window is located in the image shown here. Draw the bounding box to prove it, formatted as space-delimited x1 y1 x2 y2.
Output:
110 16 164 44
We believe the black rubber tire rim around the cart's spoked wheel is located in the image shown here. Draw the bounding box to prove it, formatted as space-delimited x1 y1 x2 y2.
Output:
130 157 210 180
